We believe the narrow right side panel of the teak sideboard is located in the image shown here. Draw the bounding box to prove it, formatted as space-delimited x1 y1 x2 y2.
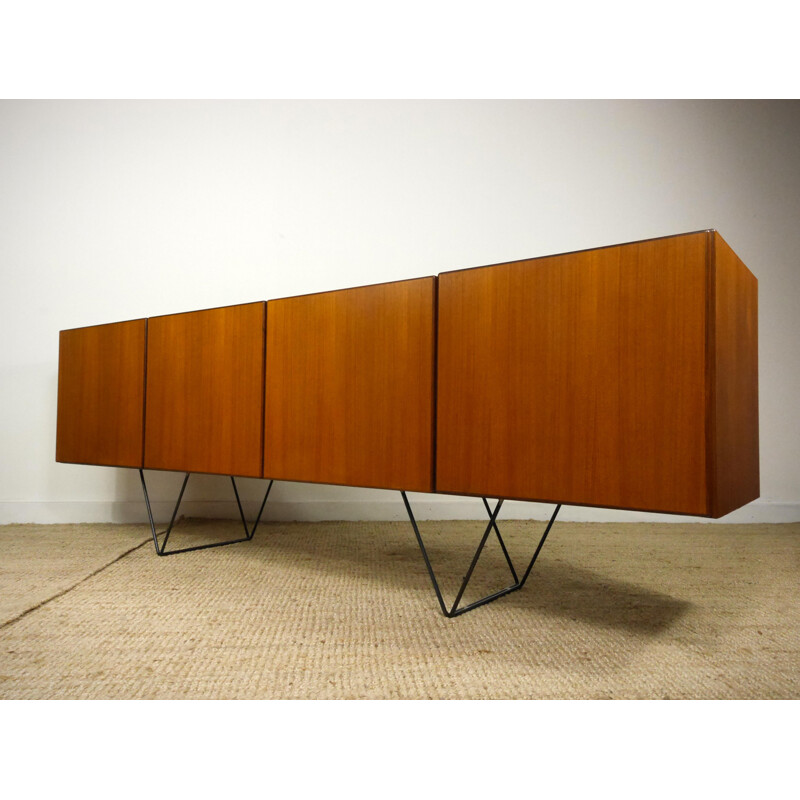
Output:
712 232 760 517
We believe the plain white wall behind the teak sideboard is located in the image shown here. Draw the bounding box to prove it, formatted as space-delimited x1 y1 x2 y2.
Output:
0 101 800 522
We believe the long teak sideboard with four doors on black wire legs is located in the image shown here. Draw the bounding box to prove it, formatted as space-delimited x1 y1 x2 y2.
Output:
56 230 759 616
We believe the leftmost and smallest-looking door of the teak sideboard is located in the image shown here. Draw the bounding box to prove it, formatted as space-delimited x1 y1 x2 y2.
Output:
56 319 146 467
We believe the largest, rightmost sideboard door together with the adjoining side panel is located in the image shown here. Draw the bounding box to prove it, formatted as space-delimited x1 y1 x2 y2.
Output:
436 231 759 517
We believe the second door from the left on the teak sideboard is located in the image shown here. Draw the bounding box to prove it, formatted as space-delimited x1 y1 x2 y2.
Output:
144 302 266 477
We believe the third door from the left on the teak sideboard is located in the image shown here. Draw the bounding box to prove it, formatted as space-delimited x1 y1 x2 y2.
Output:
264 278 436 492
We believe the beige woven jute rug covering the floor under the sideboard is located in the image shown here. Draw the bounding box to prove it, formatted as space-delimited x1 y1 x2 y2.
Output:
0 520 800 699
